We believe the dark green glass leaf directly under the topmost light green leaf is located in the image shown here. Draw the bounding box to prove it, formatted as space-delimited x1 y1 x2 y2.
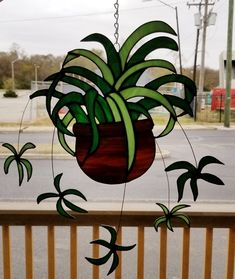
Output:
127 36 178 68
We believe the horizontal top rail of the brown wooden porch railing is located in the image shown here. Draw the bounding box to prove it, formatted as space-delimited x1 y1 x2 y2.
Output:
0 202 235 228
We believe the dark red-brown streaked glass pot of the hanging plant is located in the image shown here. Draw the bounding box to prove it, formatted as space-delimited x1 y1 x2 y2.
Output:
73 119 155 184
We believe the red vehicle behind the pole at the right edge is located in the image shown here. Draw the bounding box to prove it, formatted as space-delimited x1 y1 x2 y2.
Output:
211 88 235 110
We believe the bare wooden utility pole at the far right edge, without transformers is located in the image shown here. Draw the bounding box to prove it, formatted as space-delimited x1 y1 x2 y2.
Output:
224 0 234 128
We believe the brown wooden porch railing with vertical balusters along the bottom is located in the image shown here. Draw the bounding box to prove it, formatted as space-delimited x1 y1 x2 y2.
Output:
0 203 235 279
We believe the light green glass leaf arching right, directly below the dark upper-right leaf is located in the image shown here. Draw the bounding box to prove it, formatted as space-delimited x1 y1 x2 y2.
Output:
115 59 176 91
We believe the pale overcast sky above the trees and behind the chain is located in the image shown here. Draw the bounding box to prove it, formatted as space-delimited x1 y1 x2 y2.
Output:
0 0 235 69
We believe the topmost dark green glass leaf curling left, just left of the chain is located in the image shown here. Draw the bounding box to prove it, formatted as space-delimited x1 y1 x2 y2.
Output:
82 33 121 78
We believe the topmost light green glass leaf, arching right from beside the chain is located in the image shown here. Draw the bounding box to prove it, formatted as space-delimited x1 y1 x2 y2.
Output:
119 21 176 69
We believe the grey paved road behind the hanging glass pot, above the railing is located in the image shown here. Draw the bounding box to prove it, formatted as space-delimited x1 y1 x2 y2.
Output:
0 130 235 202
